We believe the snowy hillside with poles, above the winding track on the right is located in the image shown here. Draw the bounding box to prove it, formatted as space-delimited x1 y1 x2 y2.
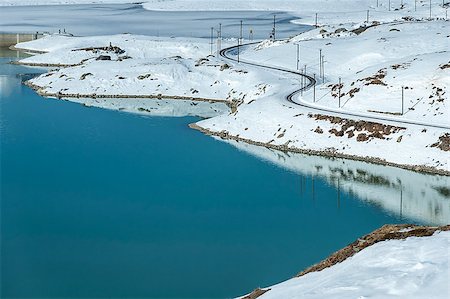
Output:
241 21 450 127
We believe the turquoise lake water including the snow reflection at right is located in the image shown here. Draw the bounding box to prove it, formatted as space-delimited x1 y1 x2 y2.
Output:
0 48 450 298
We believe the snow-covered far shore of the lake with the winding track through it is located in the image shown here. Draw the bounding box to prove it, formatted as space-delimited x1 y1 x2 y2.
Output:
17 14 449 171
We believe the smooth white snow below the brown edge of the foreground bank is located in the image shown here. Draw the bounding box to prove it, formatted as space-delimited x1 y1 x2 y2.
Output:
237 231 450 299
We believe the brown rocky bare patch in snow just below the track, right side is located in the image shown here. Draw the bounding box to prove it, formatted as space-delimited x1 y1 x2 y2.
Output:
308 114 406 141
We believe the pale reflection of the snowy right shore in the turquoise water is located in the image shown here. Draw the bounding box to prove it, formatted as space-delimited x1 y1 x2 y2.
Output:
230 142 450 225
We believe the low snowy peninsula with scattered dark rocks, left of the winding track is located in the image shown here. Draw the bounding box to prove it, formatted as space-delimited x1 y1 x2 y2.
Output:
17 34 295 117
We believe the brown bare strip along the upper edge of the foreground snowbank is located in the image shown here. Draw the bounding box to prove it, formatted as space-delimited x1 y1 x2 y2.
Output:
296 224 450 277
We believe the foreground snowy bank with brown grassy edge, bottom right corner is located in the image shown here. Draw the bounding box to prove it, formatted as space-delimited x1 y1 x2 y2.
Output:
239 224 450 299
